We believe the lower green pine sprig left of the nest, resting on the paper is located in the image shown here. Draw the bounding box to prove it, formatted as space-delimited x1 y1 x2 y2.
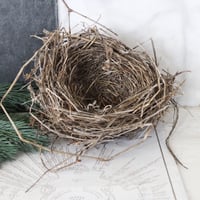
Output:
0 113 49 163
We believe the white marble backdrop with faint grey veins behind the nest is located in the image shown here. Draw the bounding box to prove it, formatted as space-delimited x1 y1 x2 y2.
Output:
58 0 200 106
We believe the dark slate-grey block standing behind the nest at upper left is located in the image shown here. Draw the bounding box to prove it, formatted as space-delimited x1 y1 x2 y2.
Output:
0 0 57 82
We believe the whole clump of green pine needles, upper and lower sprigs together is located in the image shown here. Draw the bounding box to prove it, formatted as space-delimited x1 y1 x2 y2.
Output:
0 83 49 164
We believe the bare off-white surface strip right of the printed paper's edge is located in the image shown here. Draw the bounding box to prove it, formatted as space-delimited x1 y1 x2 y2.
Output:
171 107 200 200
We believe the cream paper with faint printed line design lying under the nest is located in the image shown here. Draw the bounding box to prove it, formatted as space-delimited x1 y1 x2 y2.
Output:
0 111 187 200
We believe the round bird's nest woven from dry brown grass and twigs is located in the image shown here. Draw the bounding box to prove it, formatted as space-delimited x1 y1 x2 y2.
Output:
27 28 177 145
